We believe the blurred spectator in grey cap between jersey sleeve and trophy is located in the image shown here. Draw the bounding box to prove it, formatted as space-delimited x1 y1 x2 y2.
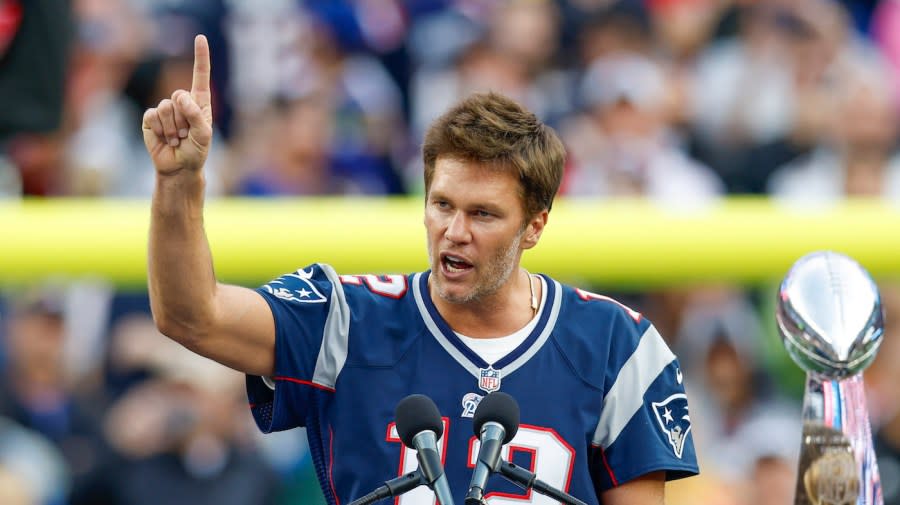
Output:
674 293 801 483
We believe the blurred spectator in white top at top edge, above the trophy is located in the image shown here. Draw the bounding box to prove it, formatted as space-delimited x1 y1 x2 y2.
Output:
694 0 877 193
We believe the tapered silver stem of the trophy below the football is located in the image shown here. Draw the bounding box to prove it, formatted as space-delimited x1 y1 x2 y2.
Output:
794 373 884 505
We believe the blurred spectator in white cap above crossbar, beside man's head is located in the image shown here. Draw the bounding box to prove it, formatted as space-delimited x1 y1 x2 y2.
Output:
563 55 723 208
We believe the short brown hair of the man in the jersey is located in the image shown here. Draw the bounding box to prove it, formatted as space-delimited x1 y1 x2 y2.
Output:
422 92 566 218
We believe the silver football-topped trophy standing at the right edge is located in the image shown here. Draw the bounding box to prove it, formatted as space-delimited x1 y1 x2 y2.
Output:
775 251 884 505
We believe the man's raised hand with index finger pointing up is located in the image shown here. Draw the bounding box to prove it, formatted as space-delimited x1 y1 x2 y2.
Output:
142 35 212 175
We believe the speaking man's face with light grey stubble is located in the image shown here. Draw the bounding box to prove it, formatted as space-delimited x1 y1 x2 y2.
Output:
425 158 546 303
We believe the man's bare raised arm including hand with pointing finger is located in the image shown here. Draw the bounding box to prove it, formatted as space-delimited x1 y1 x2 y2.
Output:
142 35 275 375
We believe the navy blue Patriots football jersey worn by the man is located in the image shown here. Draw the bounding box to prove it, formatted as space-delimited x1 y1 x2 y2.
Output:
247 264 698 505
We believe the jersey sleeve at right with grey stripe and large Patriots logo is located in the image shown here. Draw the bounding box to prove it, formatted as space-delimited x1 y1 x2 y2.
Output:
591 313 699 492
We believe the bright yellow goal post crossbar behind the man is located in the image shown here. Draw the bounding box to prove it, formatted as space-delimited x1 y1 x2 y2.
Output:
0 197 900 289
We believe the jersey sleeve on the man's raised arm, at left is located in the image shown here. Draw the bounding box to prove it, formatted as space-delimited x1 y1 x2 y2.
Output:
246 264 350 433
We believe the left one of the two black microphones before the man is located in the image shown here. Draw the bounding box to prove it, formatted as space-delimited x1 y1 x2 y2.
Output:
394 395 454 505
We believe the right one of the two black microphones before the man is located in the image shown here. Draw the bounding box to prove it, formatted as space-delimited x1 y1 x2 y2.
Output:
466 391 519 505
